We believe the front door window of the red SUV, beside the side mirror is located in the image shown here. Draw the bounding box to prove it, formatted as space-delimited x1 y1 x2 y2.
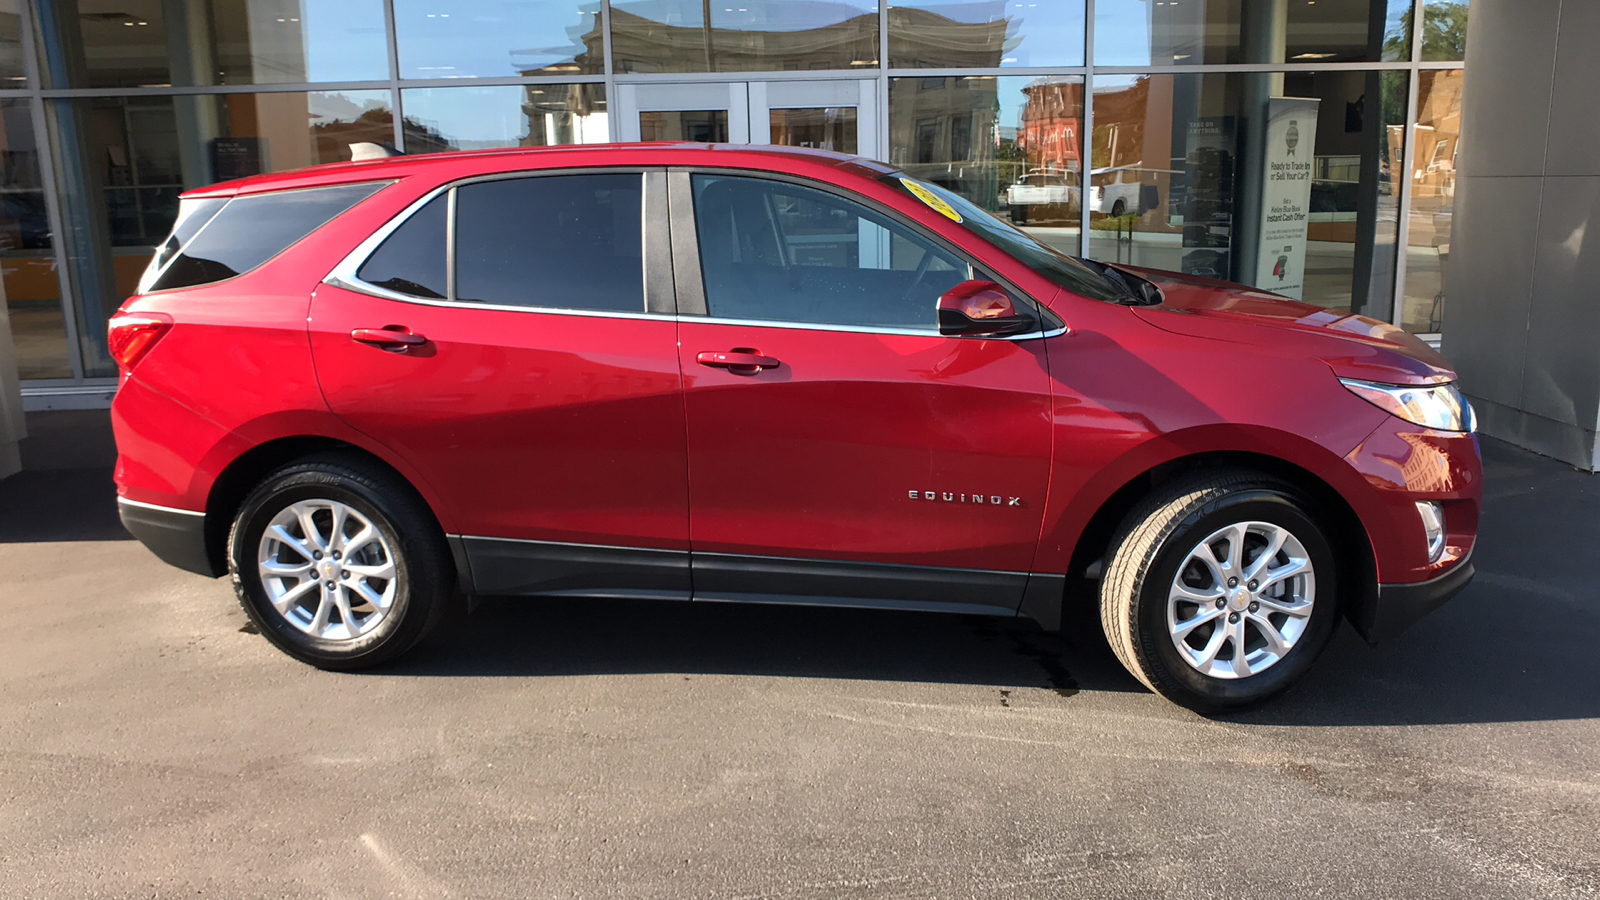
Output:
694 175 968 331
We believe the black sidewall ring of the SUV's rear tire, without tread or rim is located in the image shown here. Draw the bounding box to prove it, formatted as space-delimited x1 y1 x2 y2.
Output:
227 471 416 665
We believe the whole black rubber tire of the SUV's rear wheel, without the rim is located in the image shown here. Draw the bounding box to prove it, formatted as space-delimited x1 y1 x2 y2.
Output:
227 453 456 671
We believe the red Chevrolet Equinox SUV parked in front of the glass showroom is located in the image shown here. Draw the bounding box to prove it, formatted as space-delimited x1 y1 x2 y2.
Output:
110 144 1482 709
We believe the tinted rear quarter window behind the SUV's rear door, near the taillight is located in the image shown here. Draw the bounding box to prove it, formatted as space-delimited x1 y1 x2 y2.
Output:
139 183 387 293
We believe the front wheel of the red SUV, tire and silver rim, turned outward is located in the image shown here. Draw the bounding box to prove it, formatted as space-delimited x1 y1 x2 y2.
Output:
1101 471 1338 713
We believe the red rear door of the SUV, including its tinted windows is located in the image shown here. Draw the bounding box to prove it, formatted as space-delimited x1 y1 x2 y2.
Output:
310 170 688 597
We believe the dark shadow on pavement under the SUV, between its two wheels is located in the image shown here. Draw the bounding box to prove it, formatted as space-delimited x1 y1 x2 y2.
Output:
384 599 1142 697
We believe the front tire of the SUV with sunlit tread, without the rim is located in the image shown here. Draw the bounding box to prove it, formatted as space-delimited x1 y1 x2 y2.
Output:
1101 471 1339 713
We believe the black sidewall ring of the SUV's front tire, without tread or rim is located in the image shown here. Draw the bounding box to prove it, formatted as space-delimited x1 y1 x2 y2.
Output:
1134 490 1339 709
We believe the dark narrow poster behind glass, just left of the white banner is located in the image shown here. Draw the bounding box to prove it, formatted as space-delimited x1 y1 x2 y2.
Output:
1182 115 1238 280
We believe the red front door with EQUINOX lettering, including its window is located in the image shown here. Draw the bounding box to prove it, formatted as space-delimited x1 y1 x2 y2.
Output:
669 171 1051 612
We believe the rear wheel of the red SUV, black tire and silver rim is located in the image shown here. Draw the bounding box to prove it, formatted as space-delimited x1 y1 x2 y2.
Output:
227 455 454 669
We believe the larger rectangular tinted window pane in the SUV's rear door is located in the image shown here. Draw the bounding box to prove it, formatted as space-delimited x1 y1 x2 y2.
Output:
456 173 645 312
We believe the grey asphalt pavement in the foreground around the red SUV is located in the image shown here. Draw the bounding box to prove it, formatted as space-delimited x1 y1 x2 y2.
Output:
0 440 1600 900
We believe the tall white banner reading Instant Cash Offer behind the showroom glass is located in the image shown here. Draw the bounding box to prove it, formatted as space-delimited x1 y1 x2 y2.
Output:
1251 98 1317 299
